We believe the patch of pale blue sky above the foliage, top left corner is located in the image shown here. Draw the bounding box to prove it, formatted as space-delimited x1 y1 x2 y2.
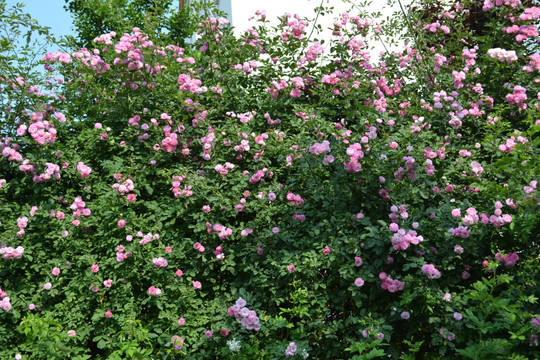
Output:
6 0 73 37
